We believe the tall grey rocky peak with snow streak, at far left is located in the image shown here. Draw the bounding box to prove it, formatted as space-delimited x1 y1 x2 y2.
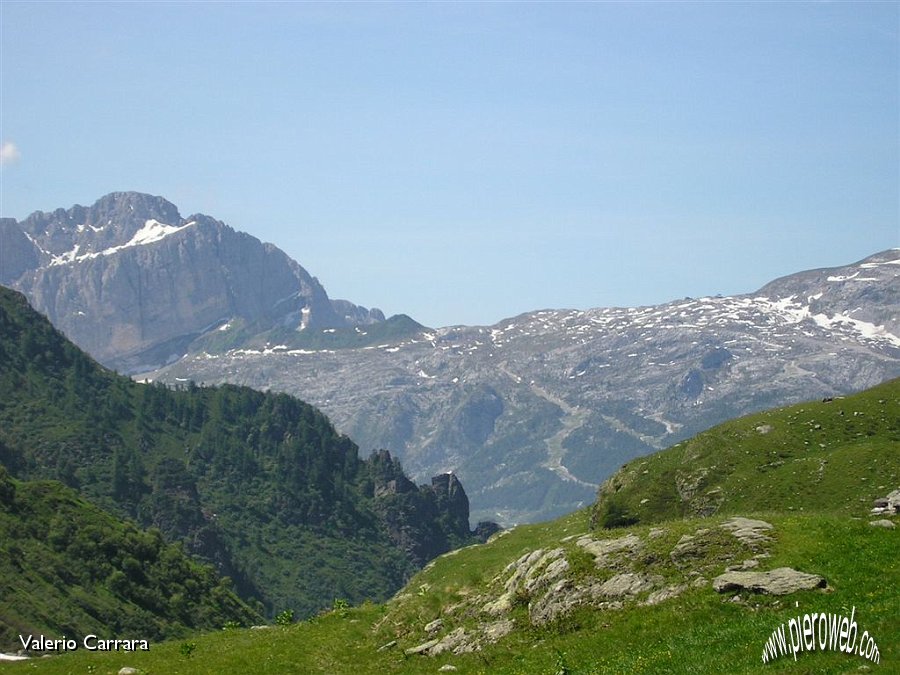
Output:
0 192 396 372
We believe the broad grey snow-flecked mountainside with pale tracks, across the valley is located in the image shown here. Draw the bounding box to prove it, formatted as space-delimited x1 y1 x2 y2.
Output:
152 249 900 523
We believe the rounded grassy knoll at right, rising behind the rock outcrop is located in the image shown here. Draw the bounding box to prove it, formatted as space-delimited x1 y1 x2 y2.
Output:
596 380 900 525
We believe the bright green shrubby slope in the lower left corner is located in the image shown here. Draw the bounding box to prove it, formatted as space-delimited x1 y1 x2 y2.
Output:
0 466 261 650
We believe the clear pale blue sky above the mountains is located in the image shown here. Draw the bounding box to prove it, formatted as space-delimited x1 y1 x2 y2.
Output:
0 0 900 326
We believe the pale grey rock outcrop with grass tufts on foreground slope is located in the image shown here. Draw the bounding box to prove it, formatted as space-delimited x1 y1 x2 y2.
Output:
388 517 825 656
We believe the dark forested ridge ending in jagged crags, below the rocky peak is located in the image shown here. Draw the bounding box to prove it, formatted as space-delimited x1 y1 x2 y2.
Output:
0 288 489 615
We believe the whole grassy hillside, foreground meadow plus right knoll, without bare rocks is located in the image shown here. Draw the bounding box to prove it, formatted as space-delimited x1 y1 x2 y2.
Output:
10 382 900 674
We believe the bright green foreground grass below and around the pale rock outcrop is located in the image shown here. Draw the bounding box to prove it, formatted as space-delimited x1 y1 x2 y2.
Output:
8 512 900 675
